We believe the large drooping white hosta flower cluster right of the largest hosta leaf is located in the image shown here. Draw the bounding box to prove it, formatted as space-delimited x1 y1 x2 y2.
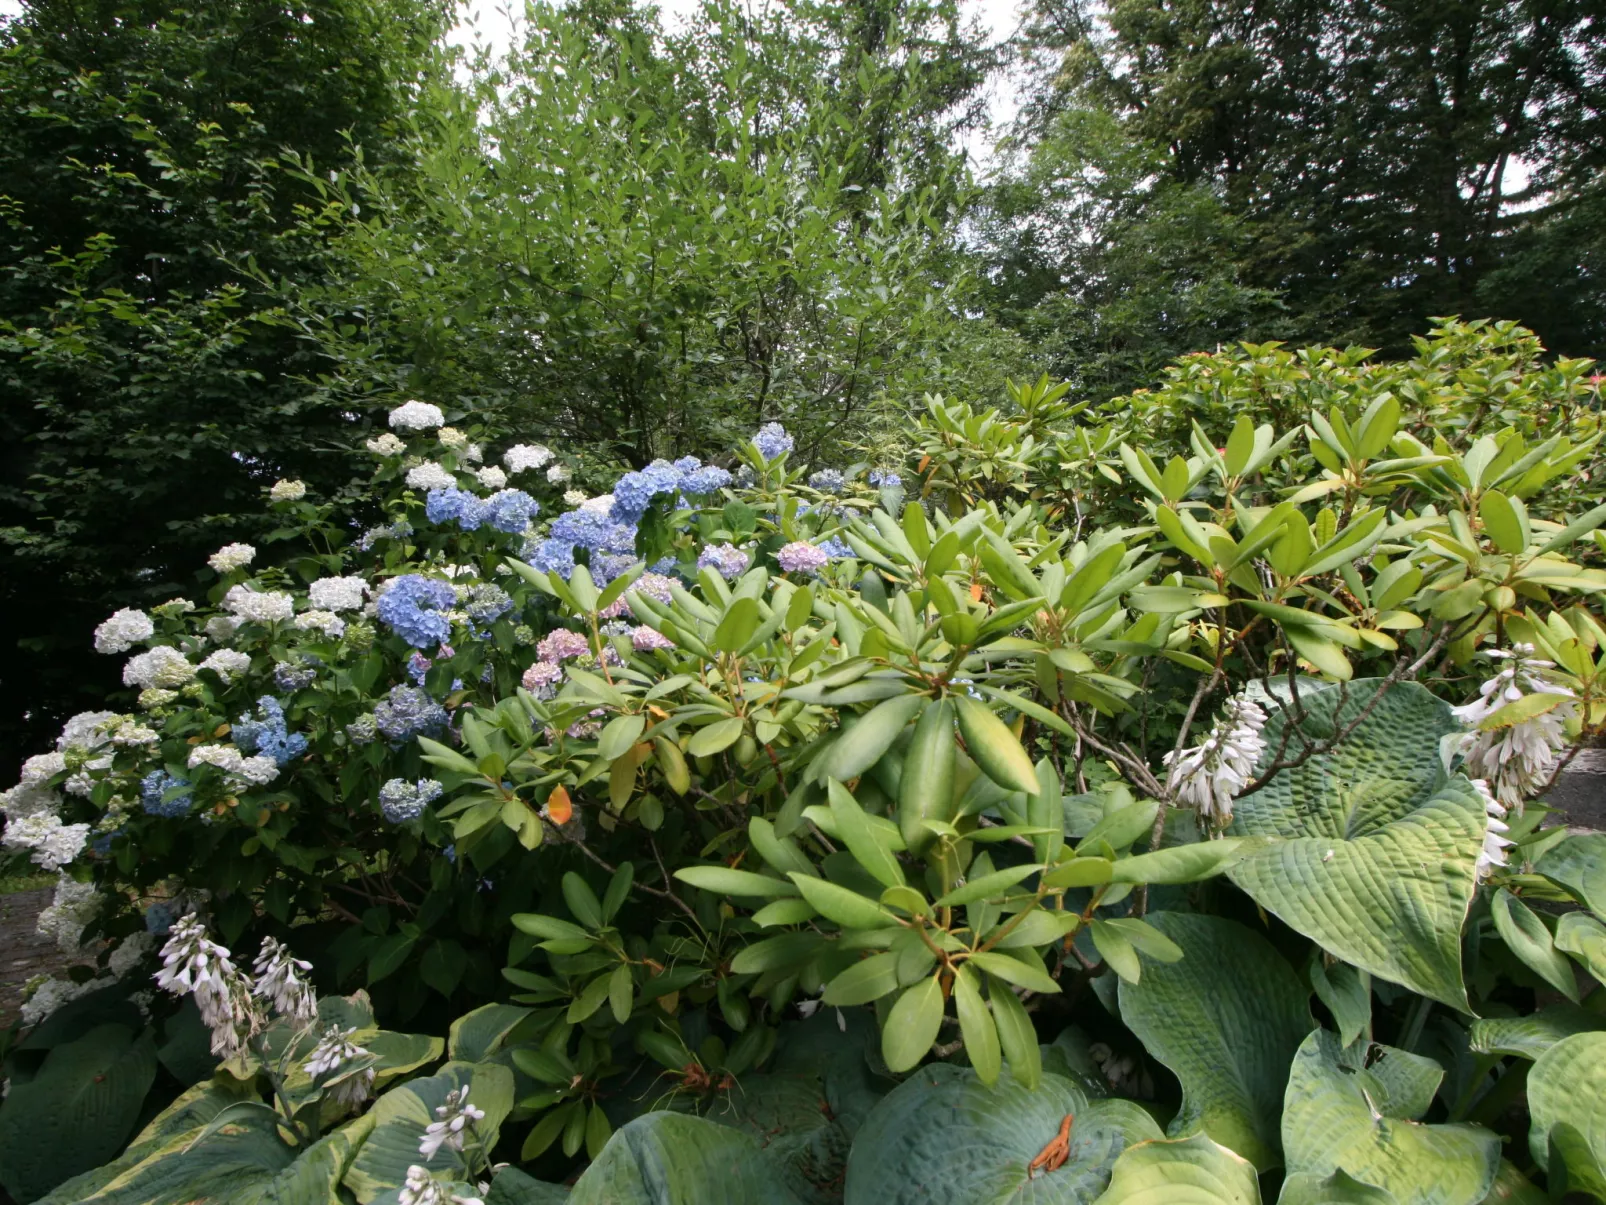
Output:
1450 644 1577 816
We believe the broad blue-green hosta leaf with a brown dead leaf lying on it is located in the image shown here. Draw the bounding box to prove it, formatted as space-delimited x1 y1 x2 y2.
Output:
843 1064 1161 1205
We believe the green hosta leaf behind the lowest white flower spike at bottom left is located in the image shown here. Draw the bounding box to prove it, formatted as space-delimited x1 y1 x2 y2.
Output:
344 1062 514 1205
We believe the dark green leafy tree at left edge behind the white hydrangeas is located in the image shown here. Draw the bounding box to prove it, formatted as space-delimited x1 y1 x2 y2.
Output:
0 0 443 774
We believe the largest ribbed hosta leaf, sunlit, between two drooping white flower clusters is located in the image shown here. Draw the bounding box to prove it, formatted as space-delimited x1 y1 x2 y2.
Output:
1229 680 1484 1012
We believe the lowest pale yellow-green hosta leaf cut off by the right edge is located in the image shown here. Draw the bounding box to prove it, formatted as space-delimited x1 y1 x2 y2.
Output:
1527 1033 1606 1200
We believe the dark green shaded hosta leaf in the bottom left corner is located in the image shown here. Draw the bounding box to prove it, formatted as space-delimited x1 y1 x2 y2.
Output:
0 1025 156 1200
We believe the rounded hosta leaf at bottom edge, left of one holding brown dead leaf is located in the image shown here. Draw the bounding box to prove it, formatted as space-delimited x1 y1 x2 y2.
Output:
569 1113 801 1205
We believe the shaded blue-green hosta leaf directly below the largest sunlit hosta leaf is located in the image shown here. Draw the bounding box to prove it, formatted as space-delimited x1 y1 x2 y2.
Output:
1119 913 1315 1171
